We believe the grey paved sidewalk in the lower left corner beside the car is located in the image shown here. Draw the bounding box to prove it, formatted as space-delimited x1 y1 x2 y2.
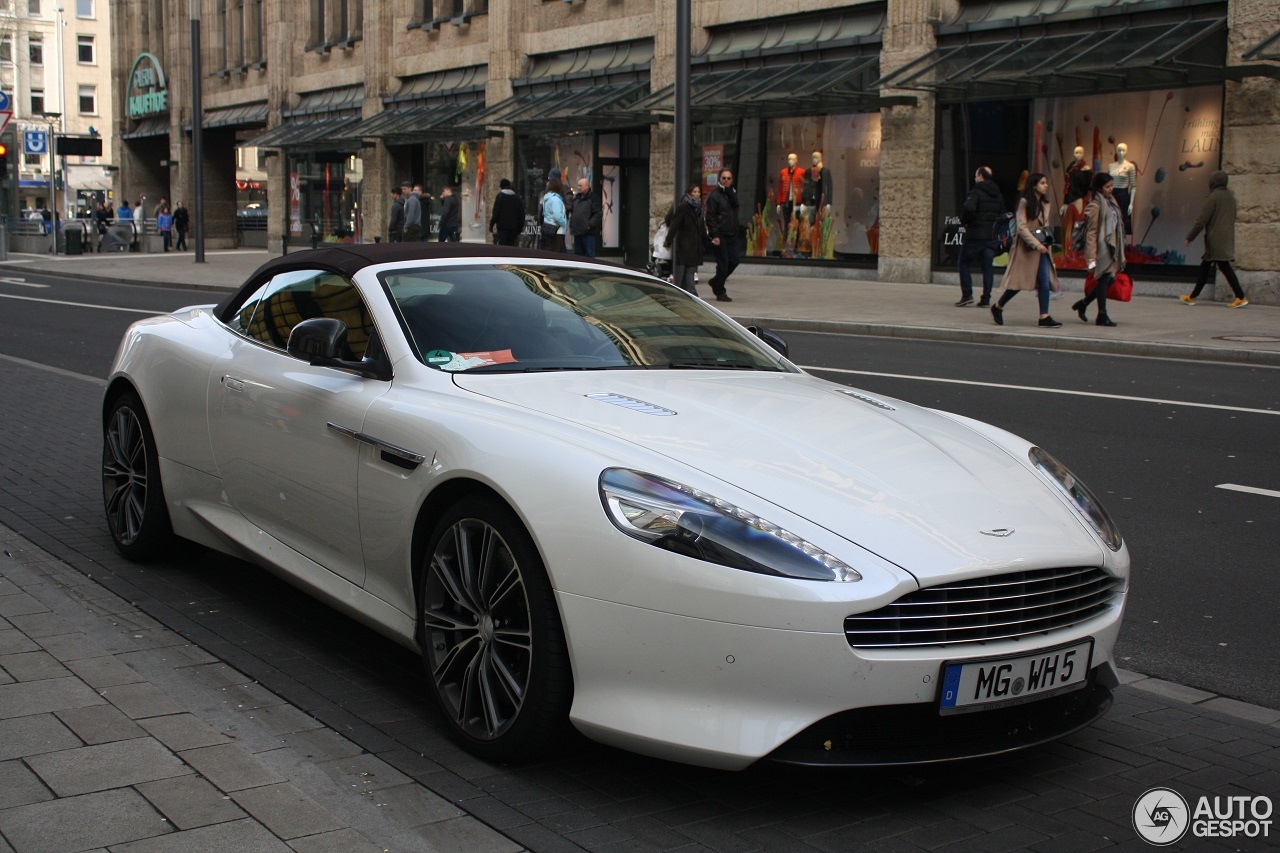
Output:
0 517 521 853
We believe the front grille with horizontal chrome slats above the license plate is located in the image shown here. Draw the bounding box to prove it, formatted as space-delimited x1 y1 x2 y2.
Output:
845 567 1124 648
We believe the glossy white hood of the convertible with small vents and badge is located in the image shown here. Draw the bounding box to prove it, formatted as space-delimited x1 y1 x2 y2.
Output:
456 370 1102 585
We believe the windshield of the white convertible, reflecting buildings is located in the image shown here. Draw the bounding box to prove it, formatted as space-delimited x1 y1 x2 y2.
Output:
379 264 794 373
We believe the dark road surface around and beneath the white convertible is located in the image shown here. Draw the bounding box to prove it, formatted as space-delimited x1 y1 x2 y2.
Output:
0 277 1280 852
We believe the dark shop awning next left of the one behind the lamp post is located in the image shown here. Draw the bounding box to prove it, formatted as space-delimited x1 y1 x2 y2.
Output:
466 81 657 134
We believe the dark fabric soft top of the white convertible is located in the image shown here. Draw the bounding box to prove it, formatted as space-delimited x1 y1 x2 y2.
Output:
215 242 636 321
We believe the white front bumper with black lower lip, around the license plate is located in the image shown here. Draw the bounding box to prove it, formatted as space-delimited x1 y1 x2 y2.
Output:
558 593 1123 770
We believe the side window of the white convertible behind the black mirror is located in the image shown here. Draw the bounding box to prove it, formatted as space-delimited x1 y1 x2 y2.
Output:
228 270 374 361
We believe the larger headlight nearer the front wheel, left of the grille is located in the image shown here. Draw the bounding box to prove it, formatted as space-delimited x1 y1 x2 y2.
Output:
600 467 863 583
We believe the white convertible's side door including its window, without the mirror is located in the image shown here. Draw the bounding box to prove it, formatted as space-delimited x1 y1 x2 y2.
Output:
209 270 390 584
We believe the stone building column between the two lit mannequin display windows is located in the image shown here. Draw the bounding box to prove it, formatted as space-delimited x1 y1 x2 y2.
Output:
879 0 959 282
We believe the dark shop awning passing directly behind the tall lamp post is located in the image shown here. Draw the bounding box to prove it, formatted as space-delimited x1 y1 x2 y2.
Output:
632 55 881 122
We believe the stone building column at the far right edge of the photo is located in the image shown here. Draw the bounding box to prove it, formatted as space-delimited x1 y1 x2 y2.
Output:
1206 0 1280 305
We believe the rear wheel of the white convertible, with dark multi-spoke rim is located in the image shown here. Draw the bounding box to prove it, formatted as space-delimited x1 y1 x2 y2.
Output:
102 392 177 560
